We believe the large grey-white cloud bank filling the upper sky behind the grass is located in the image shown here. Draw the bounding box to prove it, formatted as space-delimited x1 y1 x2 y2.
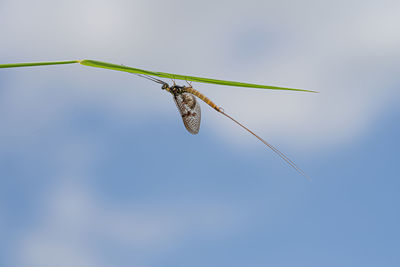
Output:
0 0 400 153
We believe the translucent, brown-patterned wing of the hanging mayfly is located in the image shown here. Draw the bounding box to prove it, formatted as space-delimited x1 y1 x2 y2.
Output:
174 93 201 134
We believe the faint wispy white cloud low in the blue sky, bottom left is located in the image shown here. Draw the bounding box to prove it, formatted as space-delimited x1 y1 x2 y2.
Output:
14 182 241 266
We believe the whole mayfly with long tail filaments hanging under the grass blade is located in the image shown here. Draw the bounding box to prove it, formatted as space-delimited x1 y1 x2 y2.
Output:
136 74 310 180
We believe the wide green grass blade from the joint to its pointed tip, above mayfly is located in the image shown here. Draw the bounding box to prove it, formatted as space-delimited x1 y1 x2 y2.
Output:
80 59 317 93
